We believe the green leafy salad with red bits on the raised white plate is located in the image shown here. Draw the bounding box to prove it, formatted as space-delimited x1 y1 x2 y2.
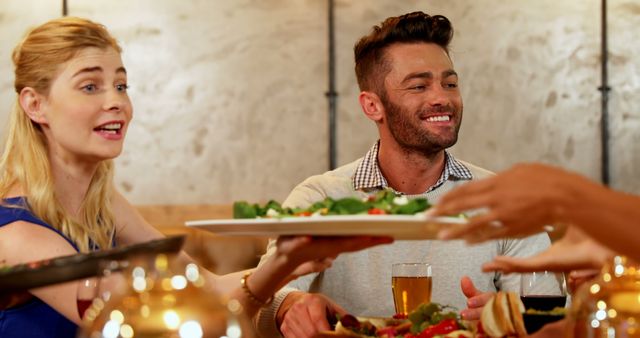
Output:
233 190 431 218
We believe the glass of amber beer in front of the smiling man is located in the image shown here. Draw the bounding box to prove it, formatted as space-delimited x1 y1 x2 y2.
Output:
391 263 431 315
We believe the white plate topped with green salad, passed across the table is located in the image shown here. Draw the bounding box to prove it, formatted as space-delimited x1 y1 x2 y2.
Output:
186 190 467 240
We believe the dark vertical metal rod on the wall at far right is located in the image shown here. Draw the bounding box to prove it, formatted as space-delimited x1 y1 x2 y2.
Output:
598 0 611 185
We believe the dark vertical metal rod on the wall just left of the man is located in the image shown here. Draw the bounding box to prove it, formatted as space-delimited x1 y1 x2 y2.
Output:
325 0 338 170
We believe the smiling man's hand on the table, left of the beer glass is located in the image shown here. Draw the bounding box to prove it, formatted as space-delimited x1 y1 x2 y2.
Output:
276 292 347 338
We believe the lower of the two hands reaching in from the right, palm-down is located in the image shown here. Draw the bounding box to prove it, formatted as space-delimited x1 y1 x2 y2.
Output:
482 226 613 273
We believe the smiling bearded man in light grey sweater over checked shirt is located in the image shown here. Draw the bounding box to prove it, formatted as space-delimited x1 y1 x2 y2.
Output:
259 12 559 337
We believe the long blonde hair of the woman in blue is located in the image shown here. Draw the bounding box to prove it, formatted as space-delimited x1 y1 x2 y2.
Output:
0 17 121 252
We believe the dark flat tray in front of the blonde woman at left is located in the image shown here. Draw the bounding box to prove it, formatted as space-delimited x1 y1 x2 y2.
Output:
0 236 185 293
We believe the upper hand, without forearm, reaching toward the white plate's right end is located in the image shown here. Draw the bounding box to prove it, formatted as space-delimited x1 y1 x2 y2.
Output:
432 164 593 243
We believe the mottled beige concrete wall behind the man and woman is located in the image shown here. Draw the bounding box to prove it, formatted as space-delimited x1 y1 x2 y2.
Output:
0 0 640 204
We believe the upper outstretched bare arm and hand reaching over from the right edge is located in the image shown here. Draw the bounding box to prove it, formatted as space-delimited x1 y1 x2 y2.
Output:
433 164 640 259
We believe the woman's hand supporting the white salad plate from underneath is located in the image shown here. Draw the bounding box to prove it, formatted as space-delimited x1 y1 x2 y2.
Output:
276 236 393 279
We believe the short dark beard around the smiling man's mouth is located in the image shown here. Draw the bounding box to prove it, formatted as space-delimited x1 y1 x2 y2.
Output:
381 93 462 155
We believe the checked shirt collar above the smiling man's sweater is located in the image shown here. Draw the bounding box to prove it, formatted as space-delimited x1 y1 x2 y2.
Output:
351 140 473 193
